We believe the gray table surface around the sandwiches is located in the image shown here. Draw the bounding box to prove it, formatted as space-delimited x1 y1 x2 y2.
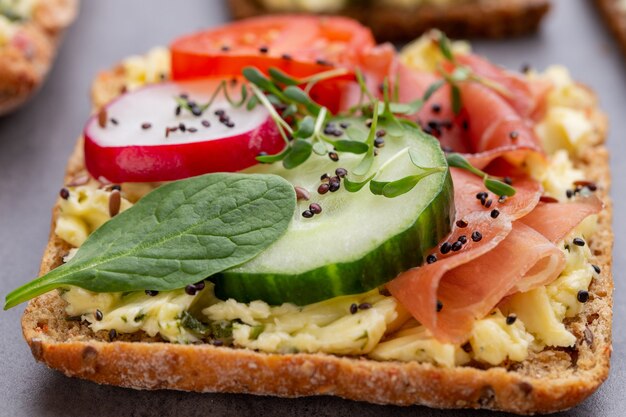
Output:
0 0 626 416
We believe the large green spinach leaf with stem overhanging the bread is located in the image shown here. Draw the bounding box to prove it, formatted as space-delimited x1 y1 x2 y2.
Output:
4 173 296 310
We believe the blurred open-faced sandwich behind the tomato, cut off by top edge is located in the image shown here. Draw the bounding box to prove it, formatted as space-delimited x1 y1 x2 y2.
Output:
228 0 548 41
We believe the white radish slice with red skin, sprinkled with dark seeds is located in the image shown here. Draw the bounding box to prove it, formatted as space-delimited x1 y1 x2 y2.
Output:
84 79 284 182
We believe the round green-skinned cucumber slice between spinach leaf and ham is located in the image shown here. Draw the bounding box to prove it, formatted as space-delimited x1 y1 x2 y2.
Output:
214 119 454 305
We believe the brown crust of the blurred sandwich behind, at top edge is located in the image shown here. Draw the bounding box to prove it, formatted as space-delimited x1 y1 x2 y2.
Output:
228 0 550 42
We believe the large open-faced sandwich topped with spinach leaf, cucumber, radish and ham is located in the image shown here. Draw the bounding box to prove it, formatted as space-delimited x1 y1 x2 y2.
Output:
5 16 613 413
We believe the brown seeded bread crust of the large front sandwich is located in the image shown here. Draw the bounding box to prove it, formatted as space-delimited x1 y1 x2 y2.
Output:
22 70 613 414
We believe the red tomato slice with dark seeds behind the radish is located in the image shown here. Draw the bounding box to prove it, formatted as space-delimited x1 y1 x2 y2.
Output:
170 15 375 80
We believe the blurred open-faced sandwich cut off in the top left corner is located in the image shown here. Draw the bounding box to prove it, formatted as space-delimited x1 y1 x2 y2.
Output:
0 0 78 115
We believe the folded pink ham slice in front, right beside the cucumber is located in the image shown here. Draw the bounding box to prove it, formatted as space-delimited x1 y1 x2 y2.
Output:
387 170 601 343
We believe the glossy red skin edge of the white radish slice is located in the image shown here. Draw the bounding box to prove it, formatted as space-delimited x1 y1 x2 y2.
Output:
84 116 284 182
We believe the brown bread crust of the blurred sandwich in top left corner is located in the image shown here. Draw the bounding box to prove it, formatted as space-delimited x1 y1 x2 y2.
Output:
0 0 78 116
